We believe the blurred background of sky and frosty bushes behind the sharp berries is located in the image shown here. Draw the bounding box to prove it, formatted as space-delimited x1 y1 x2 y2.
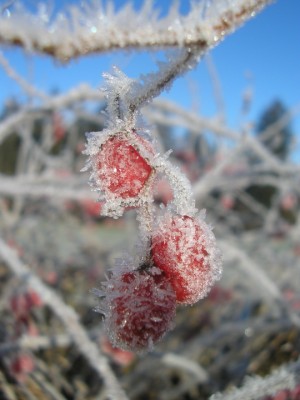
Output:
0 0 300 400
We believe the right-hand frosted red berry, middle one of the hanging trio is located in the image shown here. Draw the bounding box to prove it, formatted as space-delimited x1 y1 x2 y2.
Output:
151 213 221 304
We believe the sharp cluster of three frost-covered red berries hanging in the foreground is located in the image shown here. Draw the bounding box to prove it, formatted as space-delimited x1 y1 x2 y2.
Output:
85 70 221 351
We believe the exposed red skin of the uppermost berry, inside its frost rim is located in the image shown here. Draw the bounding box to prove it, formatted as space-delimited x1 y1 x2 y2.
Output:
97 133 153 199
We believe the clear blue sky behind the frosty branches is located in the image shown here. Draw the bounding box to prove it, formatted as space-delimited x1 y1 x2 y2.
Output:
0 0 300 159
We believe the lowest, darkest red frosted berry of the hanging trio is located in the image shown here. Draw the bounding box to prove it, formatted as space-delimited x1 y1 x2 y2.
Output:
103 267 176 352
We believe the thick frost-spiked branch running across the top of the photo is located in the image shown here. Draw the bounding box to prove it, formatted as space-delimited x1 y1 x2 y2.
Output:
0 0 270 62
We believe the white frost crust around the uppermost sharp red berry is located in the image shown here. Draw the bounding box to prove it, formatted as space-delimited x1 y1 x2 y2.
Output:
84 125 154 218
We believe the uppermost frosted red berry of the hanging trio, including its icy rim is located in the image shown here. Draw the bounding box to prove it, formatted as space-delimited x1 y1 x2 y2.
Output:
84 123 155 217
